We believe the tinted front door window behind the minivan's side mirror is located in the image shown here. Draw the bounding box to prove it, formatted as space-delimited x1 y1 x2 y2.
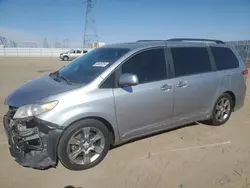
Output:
122 49 167 83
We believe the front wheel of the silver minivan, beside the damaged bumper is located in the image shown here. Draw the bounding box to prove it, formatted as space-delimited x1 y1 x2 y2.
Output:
57 119 111 171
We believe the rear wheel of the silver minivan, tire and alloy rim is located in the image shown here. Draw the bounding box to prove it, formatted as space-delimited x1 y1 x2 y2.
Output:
206 93 233 125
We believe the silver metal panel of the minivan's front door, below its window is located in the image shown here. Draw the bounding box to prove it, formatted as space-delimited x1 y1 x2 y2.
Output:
114 80 174 139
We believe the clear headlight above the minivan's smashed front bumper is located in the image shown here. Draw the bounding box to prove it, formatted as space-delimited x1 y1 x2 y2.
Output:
13 101 58 119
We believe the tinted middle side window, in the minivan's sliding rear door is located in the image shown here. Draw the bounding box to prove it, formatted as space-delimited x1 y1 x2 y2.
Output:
171 47 211 77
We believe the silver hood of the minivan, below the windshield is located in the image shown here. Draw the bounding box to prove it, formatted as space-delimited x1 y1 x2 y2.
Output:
5 74 79 107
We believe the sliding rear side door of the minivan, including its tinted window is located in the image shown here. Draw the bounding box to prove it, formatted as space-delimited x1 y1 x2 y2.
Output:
171 46 219 124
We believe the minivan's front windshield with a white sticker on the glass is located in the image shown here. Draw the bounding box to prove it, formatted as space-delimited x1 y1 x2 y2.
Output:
58 48 129 84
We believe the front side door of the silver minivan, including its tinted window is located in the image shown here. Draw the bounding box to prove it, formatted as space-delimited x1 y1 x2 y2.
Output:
114 48 174 139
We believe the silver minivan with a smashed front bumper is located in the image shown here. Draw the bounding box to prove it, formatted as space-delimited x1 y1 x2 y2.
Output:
4 39 248 170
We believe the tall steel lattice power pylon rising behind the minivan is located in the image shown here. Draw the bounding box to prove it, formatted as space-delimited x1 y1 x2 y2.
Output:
82 0 98 48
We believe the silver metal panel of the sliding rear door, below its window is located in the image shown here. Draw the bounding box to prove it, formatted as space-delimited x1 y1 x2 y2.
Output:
172 72 219 125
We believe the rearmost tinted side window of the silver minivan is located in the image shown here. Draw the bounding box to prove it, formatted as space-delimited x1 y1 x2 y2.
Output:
210 47 239 70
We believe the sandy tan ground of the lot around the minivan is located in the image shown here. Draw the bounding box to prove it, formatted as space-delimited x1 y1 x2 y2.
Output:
0 57 250 188
